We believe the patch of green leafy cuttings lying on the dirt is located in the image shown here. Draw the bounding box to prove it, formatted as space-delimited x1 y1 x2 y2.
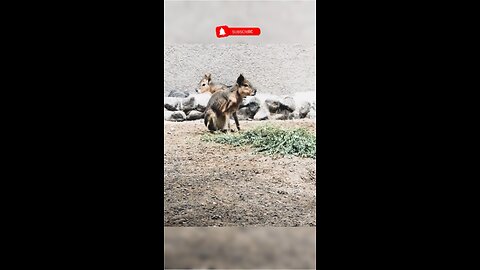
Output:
201 125 317 159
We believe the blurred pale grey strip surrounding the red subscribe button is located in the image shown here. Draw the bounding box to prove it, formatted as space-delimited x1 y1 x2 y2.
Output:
164 0 315 45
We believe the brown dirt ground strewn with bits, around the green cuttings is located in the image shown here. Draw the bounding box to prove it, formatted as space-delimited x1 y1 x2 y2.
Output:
164 119 316 227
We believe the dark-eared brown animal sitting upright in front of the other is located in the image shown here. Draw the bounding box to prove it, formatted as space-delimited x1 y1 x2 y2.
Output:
204 74 257 132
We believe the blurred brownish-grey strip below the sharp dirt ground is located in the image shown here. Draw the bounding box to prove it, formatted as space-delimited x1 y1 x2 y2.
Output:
164 227 316 269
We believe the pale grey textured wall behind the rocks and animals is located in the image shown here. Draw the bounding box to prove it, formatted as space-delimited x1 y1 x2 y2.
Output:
164 44 316 96
